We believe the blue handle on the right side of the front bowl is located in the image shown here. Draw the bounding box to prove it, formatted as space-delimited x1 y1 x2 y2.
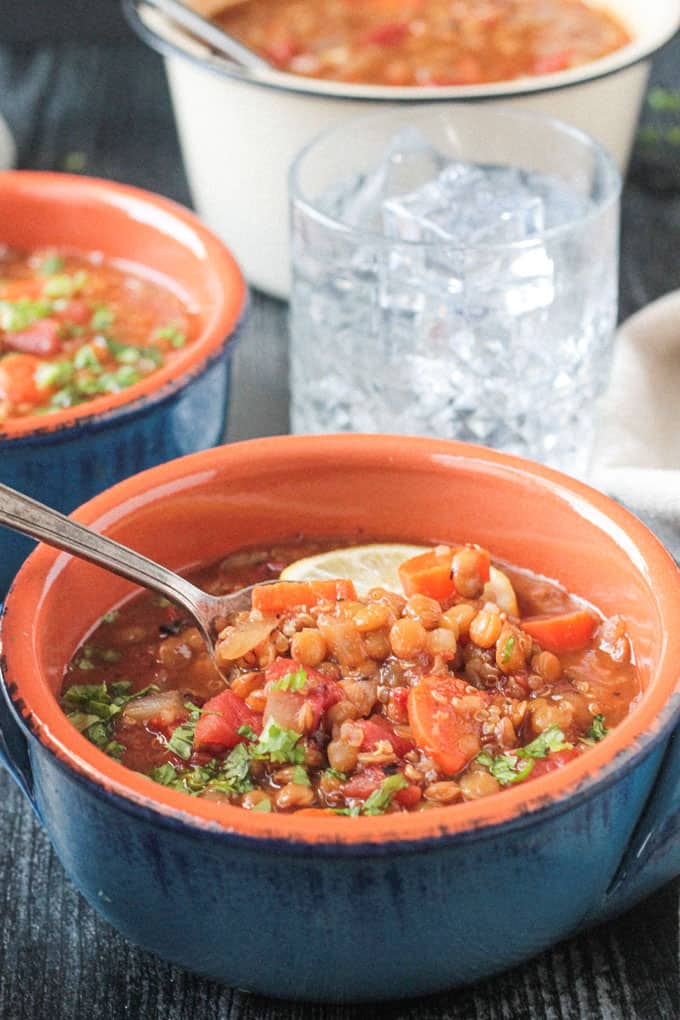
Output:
605 726 680 916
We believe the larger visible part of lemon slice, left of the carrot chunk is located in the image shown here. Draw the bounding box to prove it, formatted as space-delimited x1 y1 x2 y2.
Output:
281 543 428 595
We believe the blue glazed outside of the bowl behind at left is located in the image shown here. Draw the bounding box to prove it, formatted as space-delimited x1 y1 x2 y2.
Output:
0 344 237 596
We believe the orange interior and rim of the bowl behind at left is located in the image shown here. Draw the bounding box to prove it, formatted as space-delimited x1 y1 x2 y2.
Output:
0 170 246 438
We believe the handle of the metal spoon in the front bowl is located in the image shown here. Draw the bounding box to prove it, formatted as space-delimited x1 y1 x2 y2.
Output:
0 483 207 617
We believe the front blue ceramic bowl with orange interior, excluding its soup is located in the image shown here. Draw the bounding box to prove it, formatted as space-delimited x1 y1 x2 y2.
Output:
0 436 680 1002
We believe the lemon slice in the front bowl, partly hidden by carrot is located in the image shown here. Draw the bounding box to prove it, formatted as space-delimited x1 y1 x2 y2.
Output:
281 543 519 616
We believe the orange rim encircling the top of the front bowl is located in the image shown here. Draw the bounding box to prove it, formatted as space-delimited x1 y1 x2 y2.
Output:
3 436 680 850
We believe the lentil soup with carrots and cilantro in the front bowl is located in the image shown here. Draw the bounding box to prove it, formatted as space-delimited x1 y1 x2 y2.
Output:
61 541 640 816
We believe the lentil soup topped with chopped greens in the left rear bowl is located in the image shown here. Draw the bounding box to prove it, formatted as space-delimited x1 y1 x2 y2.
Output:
0 248 195 429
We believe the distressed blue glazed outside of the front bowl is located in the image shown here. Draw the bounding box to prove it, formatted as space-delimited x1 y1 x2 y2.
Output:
0 681 679 1002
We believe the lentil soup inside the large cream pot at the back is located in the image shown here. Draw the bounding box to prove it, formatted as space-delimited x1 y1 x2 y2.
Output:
214 0 631 86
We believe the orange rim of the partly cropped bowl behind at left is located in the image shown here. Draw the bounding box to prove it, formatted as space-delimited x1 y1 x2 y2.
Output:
0 170 247 438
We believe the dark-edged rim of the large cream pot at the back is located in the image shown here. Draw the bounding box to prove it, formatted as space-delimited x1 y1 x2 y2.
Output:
122 0 680 103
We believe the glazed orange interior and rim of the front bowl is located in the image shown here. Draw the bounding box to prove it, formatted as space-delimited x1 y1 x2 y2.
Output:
3 436 680 843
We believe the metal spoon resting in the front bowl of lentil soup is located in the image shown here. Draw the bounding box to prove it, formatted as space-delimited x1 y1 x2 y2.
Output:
0 485 275 670
